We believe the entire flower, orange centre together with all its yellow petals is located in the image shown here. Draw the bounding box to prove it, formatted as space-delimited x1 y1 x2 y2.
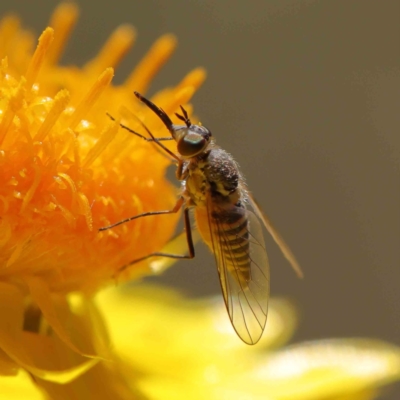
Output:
0 4 400 400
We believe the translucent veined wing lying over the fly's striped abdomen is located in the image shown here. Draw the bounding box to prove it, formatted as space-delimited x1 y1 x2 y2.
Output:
208 201 270 344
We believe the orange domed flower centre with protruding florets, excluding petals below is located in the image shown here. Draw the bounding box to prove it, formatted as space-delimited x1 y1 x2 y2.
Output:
0 5 204 292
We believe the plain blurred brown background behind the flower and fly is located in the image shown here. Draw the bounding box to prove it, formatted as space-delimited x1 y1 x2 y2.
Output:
0 0 400 398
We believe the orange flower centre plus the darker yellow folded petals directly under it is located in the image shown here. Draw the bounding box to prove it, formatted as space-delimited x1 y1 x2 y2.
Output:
0 0 205 388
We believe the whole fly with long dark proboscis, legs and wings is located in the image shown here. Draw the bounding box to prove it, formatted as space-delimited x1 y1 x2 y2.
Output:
100 92 302 344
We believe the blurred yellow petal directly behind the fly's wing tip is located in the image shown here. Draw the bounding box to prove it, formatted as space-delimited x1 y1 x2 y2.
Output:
97 285 297 383
